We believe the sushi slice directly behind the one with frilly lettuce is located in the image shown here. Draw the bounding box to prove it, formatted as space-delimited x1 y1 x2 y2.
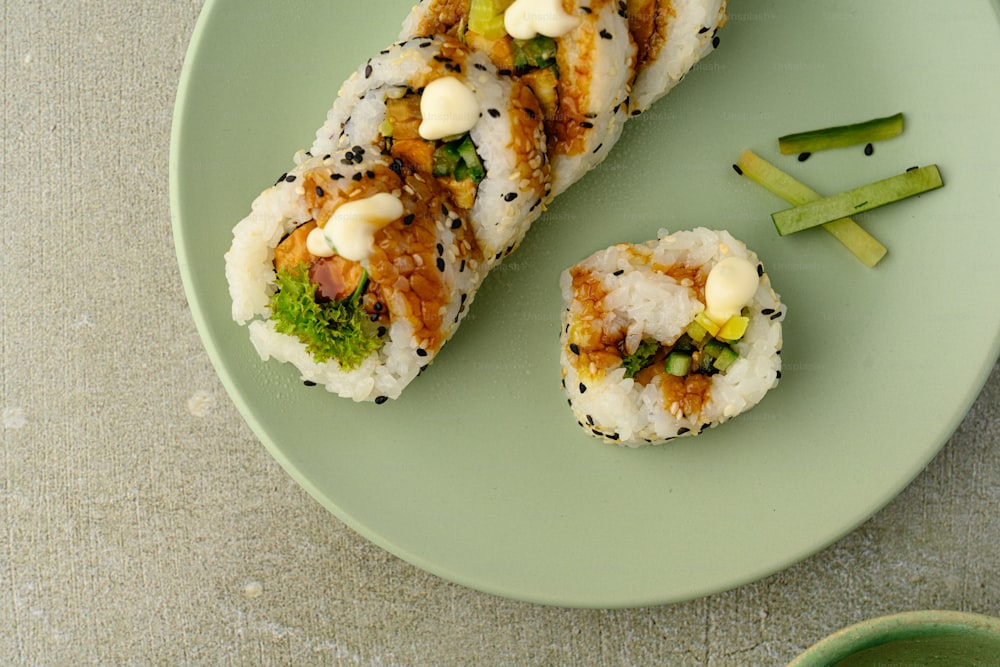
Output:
310 36 550 263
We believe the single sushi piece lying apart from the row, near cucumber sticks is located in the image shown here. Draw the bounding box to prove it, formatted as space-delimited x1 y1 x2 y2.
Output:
560 228 785 447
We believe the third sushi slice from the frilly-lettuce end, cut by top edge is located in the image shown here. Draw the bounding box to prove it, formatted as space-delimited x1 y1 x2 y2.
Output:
401 0 636 197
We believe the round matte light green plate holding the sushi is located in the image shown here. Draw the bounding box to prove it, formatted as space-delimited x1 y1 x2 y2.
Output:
170 0 1000 607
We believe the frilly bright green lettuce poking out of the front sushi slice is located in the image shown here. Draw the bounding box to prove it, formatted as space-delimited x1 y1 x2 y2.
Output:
271 263 381 369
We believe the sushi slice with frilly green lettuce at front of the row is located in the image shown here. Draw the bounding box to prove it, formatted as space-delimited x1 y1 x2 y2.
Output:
225 152 486 403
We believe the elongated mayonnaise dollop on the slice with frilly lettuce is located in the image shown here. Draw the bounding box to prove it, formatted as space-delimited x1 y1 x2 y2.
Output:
316 192 404 262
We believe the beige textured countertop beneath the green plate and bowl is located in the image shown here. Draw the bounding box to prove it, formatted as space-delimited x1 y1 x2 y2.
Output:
0 0 1000 666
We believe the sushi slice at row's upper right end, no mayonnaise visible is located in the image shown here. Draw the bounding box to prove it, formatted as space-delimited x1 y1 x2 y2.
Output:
628 0 727 115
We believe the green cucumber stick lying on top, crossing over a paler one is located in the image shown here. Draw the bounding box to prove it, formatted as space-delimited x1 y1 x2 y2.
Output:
771 164 944 236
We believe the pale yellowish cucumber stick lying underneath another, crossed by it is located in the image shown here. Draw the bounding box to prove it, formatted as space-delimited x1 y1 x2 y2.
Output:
736 150 888 267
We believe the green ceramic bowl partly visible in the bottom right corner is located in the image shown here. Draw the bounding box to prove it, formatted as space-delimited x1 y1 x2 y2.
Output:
787 611 1000 667
